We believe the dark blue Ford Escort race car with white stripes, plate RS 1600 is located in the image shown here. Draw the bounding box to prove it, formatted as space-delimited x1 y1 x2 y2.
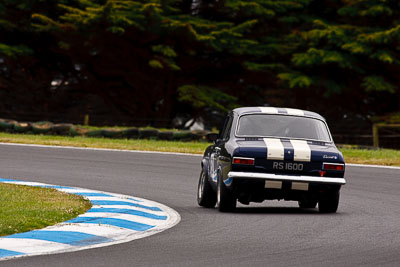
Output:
197 107 346 213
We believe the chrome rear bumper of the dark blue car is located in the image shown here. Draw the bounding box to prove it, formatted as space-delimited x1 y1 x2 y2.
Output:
228 172 346 185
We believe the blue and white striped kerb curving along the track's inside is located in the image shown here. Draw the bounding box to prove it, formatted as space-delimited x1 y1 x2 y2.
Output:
0 178 180 260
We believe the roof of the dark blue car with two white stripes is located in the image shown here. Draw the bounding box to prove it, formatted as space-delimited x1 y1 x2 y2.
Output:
233 107 325 121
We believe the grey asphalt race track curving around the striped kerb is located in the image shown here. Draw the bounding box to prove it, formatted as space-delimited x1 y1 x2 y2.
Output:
0 145 400 266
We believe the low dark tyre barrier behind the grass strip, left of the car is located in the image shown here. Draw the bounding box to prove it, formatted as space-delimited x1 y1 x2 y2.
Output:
0 119 209 142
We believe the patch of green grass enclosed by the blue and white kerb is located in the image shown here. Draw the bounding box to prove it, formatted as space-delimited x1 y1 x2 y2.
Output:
0 183 91 236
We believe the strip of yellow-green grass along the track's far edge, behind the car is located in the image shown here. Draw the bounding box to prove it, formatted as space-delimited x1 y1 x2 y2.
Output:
0 133 400 166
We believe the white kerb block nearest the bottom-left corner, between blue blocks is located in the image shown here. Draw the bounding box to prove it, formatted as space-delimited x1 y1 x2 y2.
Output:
0 238 73 254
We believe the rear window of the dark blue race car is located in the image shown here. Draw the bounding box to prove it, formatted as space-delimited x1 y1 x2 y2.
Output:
236 114 331 142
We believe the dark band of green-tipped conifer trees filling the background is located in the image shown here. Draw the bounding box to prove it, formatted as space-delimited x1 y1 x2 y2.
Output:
0 0 400 127
